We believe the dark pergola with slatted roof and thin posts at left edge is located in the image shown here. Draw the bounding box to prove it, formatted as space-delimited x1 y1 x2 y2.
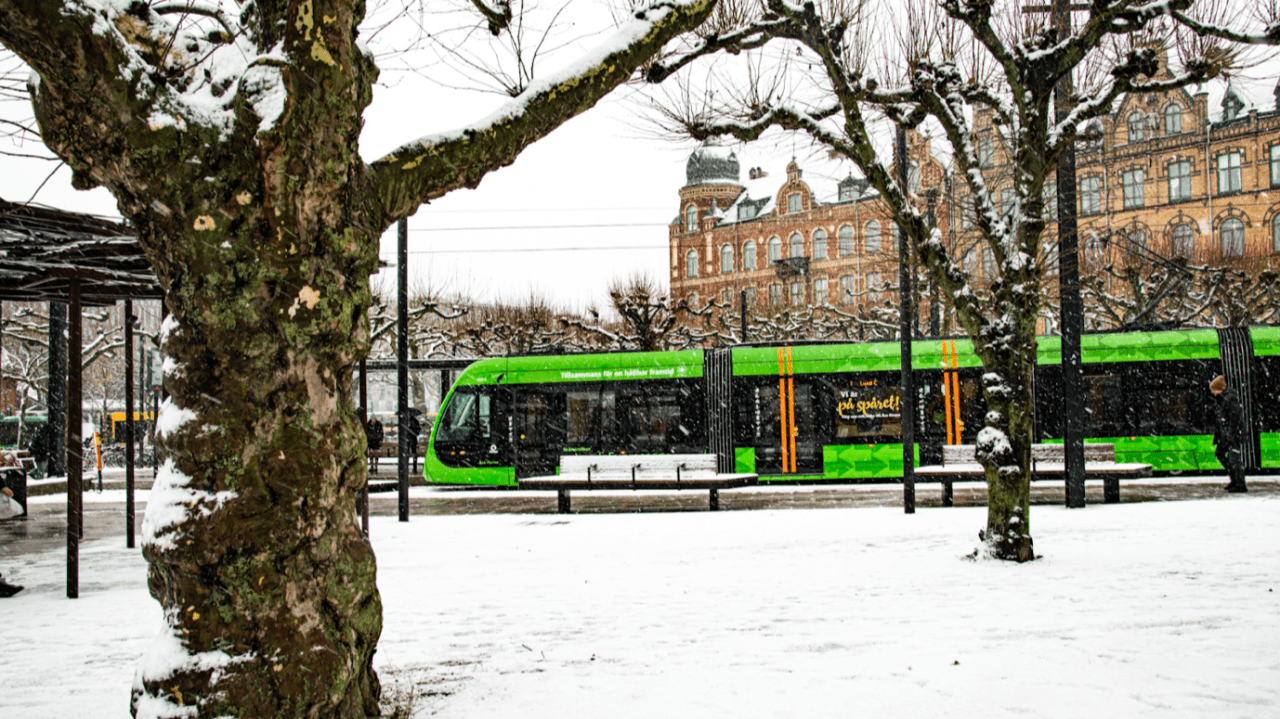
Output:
0 200 164 599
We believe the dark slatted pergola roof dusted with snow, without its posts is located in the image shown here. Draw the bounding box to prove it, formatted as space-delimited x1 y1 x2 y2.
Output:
0 200 164 304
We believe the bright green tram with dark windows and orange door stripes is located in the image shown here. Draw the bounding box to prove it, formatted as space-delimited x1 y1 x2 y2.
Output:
424 328 1280 486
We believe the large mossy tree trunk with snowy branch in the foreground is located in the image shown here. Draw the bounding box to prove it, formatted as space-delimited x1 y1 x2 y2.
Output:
0 0 714 718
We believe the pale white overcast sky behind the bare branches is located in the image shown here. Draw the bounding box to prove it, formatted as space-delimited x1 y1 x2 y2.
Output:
0 3 1275 308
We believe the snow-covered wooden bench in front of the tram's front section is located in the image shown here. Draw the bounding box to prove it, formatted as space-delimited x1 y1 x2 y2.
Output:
518 454 756 514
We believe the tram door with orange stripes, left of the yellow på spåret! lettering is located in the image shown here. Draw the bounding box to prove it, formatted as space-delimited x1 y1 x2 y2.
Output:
753 348 822 475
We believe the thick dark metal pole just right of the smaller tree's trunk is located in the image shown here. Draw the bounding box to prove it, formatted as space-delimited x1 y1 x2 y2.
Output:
1053 0 1084 508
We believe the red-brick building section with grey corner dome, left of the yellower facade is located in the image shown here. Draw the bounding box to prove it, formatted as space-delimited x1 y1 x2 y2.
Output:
669 132 947 311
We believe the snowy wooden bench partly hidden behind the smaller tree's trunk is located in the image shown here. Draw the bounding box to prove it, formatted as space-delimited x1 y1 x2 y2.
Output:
915 443 1151 507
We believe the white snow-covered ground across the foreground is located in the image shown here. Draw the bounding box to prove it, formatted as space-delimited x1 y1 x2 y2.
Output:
0 496 1280 719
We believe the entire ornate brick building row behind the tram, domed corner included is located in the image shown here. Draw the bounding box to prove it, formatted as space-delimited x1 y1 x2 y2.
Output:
669 49 1280 311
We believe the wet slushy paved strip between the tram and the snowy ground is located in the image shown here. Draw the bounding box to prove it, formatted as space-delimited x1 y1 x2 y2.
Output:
0 475 1280 557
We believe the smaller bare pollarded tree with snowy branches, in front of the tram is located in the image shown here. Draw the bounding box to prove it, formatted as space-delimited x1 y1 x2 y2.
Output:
649 0 1249 562
